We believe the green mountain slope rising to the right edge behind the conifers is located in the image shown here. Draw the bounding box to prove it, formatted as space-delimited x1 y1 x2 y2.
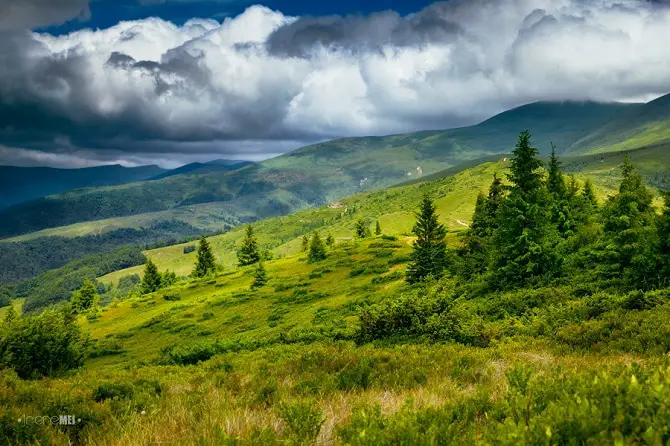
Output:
569 95 670 154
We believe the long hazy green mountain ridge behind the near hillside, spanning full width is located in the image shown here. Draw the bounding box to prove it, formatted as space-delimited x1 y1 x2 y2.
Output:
0 96 670 237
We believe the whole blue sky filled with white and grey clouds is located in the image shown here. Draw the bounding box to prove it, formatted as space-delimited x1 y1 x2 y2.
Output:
0 0 670 167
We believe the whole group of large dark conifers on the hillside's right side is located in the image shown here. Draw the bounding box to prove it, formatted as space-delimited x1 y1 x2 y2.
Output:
407 131 670 290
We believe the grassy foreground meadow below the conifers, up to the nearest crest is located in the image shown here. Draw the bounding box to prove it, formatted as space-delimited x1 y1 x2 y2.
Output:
0 237 670 445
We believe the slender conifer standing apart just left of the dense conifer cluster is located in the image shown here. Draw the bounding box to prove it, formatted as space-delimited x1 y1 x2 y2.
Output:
406 195 447 283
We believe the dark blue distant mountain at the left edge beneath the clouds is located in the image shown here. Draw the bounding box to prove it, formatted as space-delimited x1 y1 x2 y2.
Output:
0 165 165 209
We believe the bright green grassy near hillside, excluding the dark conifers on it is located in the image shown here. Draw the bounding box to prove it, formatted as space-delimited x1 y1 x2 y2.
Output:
0 139 670 446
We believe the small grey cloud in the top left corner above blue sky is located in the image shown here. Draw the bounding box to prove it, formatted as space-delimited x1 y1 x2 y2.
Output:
0 0 90 31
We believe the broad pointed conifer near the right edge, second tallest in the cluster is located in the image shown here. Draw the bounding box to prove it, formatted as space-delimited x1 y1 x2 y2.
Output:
598 155 657 288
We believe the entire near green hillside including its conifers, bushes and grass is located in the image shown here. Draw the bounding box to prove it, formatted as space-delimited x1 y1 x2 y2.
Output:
0 132 670 445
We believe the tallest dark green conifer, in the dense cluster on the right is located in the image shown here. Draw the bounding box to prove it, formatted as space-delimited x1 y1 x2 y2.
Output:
491 131 560 288
